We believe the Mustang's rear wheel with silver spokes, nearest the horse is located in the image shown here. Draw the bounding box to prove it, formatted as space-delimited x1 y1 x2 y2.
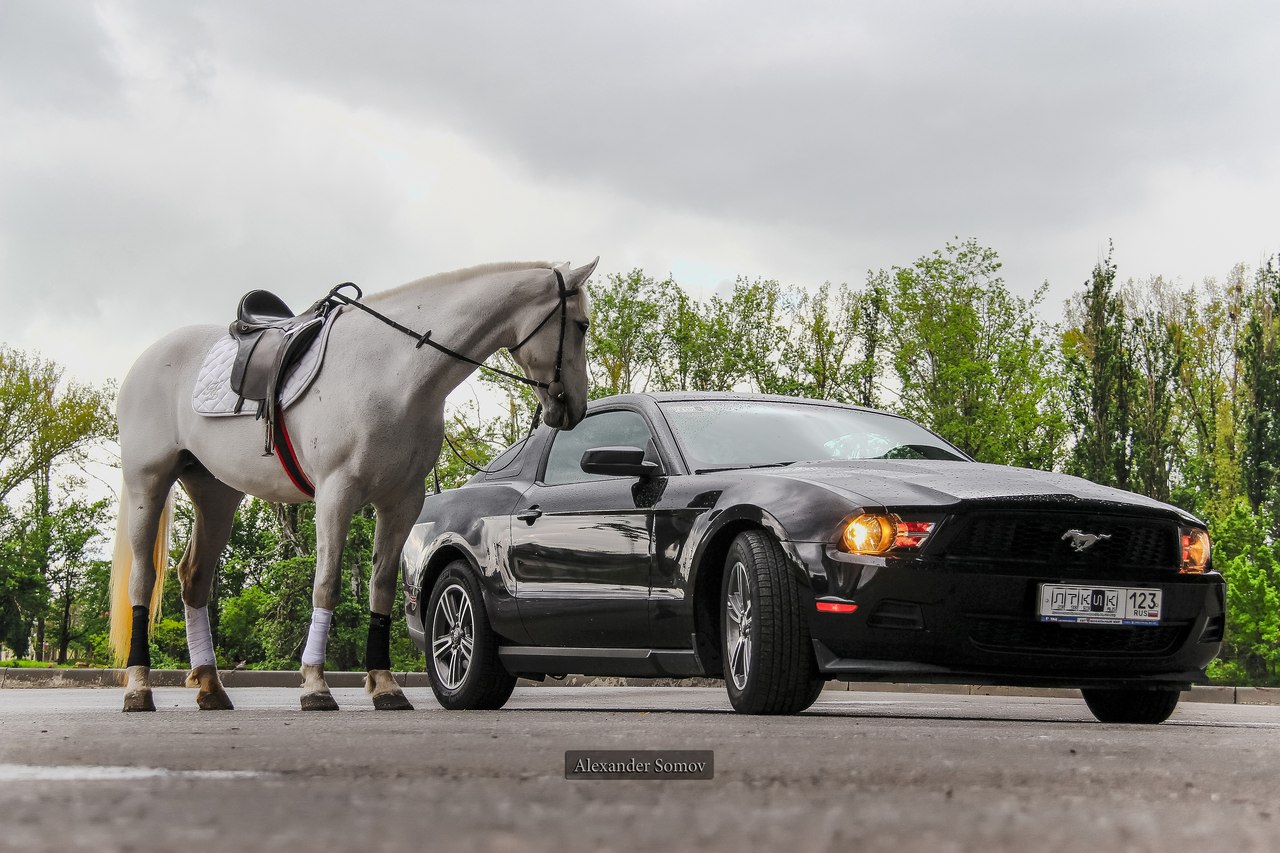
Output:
422 560 516 711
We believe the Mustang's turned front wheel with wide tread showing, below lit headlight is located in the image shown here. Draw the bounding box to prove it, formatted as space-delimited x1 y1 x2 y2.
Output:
719 530 822 715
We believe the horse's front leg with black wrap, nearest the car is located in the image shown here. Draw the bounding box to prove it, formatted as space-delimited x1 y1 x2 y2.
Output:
365 487 422 711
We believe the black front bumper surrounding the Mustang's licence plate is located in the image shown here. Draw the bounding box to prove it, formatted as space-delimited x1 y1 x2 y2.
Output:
795 543 1224 686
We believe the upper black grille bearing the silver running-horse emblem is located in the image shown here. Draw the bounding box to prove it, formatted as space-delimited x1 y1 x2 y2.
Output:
943 512 1178 569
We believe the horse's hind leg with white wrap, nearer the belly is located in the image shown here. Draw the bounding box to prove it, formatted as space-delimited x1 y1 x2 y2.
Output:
178 469 244 711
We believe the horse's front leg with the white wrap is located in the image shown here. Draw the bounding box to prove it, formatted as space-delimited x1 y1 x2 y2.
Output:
302 484 358 711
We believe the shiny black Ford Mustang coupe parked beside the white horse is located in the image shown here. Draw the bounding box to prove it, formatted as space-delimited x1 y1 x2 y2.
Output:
403 393 1224 722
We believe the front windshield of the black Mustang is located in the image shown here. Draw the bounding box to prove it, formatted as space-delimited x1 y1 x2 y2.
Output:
659 400 964 471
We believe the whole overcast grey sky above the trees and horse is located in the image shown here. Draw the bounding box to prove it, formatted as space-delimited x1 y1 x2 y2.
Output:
0 0 1280 382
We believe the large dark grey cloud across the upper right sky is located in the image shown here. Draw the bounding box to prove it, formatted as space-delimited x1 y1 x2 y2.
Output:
132 3 1276 252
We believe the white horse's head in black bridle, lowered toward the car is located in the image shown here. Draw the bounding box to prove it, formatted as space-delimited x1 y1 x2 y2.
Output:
509 257 600 429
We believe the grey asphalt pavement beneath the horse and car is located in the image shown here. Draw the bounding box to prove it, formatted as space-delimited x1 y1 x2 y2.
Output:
0 688 1280 853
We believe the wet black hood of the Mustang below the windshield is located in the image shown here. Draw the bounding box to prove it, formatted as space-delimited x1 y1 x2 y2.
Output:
759 460 1193 520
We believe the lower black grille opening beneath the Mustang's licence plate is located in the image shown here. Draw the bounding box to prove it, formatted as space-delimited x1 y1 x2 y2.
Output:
969 619 1187 654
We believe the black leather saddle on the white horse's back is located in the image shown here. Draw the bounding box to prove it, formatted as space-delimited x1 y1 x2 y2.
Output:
229 291 335 456
